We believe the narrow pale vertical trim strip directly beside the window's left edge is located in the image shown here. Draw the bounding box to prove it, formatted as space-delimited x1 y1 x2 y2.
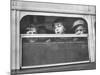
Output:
15 11 20 69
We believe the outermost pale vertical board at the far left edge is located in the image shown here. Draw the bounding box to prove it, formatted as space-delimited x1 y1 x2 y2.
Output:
11 10 16 69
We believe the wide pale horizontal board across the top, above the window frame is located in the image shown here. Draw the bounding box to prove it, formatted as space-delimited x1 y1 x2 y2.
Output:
11 1 95 14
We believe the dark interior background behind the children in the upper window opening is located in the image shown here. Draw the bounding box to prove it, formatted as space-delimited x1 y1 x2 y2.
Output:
20 15 87 34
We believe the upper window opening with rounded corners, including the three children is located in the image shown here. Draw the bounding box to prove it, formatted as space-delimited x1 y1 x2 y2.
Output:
20 15 88 34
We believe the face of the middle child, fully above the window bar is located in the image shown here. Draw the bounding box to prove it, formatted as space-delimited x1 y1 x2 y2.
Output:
54 22 64 34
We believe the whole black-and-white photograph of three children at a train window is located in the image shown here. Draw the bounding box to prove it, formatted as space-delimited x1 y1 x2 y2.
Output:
10 0 96 75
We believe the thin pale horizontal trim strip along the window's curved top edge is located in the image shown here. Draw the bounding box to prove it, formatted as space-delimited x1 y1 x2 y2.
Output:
20 11 85 20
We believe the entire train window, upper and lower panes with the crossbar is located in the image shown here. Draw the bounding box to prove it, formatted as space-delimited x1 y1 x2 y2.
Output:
20 15 89 66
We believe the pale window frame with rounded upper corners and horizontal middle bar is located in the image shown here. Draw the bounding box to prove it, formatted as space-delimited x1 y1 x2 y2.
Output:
16 11 95 68
